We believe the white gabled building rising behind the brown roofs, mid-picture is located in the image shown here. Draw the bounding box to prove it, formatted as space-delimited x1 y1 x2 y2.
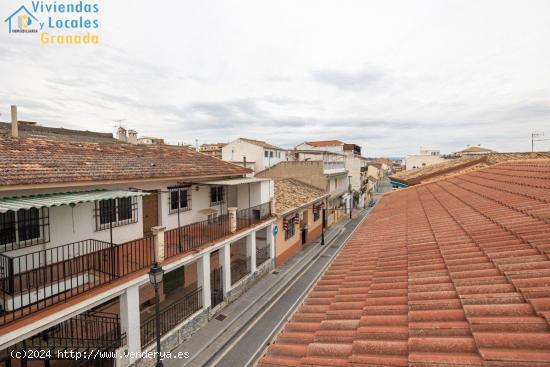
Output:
222 138 286 172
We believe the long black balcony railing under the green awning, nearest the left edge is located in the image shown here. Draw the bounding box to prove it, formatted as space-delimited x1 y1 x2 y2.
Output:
0 237 154 325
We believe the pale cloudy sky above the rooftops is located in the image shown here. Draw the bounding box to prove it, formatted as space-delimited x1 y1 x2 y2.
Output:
0 0 550 157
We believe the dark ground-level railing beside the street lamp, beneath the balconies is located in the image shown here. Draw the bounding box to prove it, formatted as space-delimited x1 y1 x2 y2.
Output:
141 287 202 348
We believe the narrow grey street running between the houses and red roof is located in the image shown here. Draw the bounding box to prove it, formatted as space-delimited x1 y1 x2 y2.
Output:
165 180 391 367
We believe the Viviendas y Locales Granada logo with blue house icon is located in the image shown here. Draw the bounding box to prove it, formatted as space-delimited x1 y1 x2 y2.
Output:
4 0 99 45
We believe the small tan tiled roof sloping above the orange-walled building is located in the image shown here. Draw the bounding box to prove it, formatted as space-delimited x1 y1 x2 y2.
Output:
274 178 327 214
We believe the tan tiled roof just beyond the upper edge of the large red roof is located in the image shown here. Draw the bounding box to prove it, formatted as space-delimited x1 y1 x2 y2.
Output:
390 152 550 186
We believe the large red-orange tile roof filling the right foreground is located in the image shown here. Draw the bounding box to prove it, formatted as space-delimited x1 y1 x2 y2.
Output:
259 160 550 367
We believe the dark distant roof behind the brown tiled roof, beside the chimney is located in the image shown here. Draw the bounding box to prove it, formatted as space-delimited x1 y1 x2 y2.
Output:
0 121 118 144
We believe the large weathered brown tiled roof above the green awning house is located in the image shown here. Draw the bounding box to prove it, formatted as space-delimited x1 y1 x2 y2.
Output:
0 137 251 186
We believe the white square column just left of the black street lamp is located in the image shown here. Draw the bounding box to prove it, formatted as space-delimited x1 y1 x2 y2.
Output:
117 285 141 366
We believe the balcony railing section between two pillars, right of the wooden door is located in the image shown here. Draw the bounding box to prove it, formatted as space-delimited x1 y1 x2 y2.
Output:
164 214 231 257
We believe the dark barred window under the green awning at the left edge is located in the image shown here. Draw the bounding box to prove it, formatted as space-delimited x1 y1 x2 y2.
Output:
0 208 50 250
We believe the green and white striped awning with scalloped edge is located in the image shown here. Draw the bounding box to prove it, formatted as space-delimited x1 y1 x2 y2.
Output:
0 190 149 213
